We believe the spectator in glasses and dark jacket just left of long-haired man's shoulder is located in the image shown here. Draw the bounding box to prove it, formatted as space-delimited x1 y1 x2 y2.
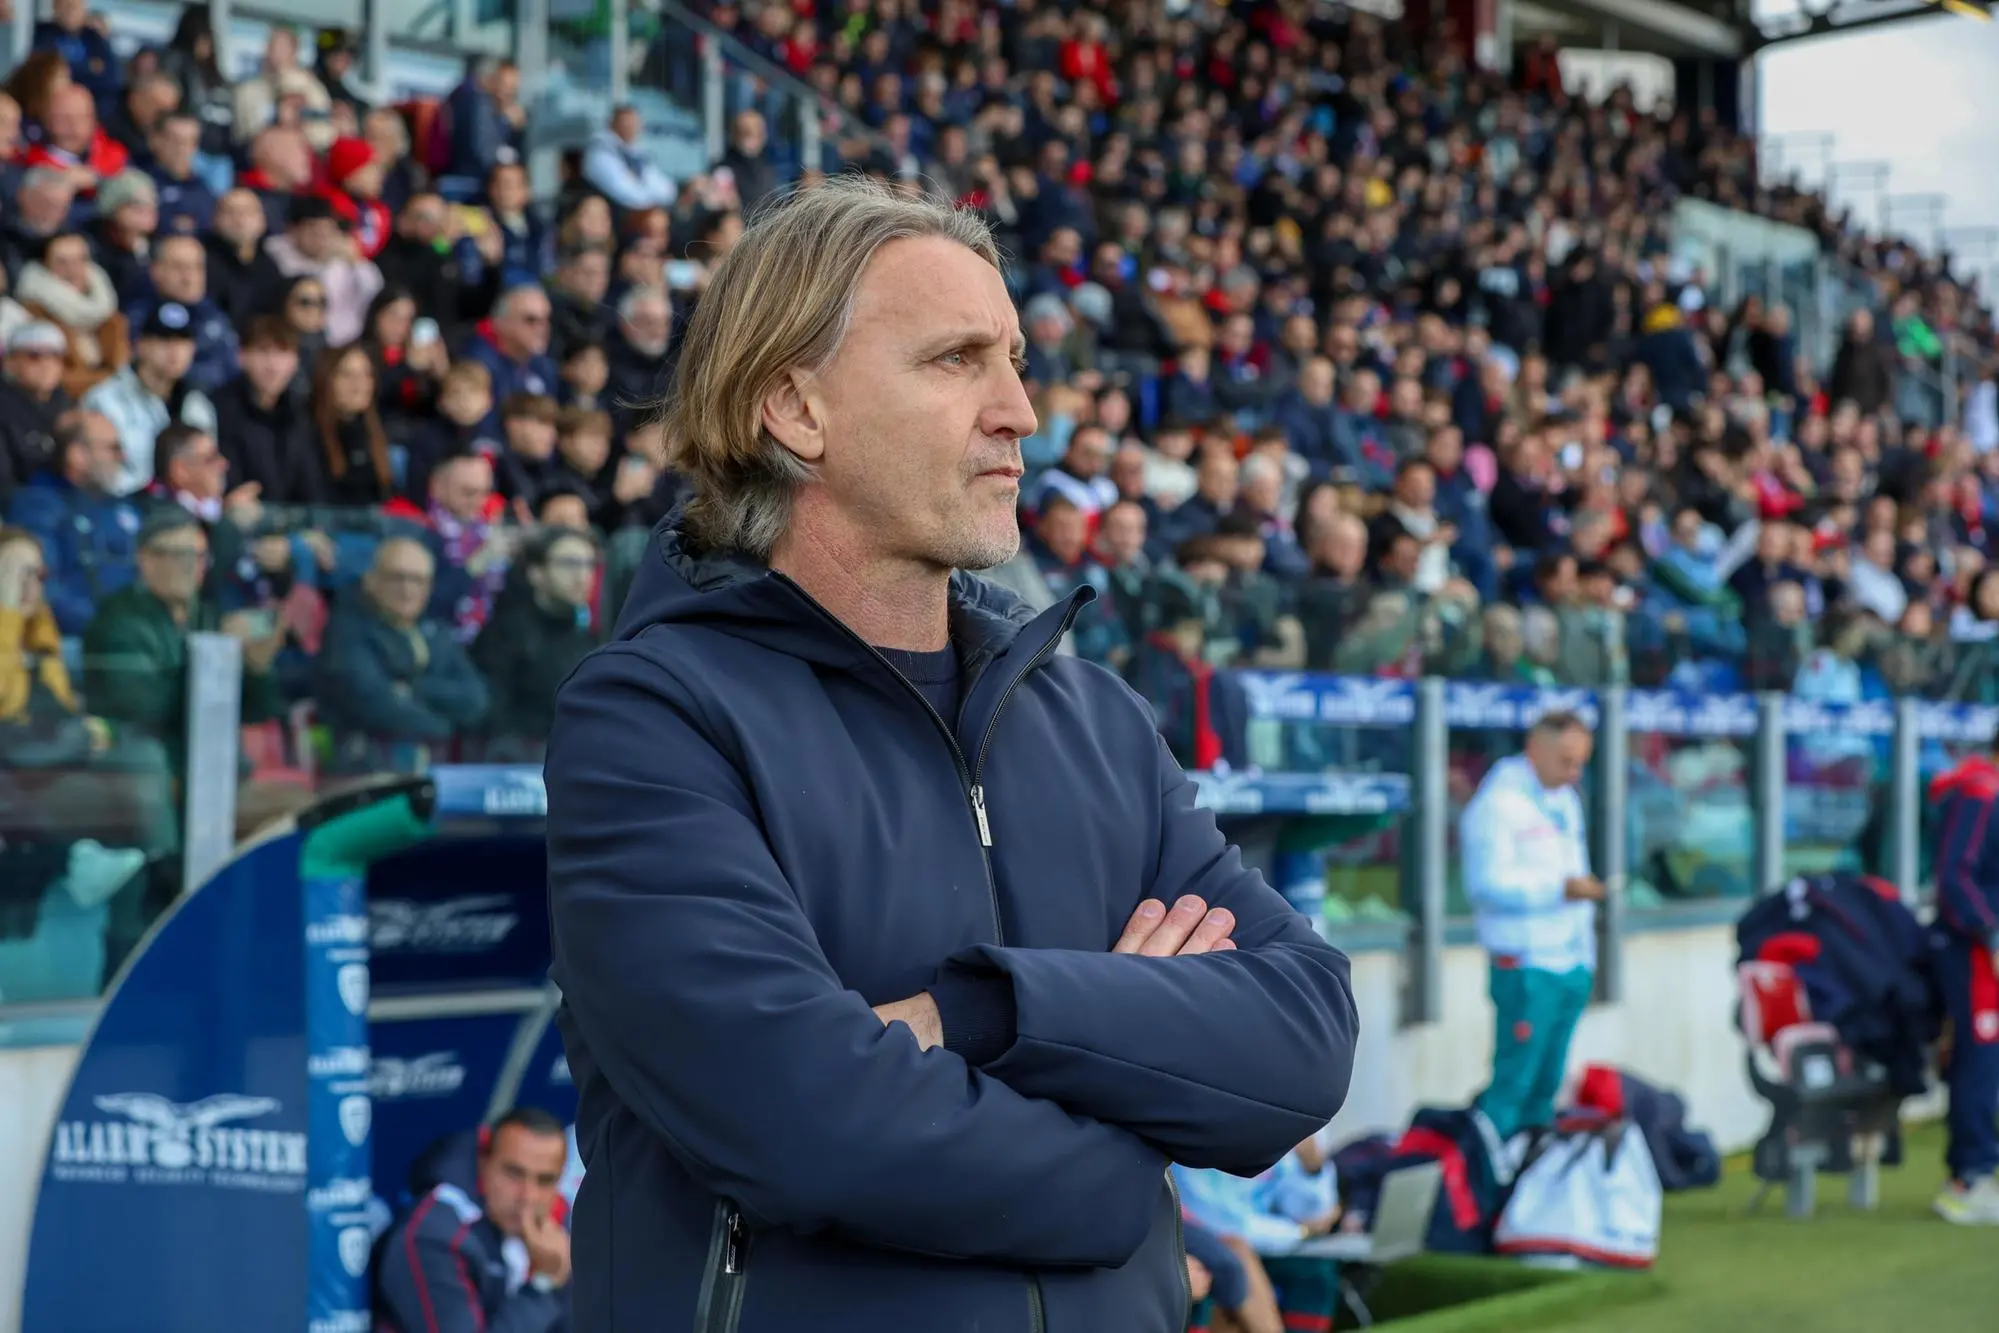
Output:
470 528 600 761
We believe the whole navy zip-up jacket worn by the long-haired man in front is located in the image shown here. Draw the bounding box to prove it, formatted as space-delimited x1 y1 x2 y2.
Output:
546 518 1355 1333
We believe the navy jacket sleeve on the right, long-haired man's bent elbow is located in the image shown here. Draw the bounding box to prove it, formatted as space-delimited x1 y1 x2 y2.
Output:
940 737 1359 1173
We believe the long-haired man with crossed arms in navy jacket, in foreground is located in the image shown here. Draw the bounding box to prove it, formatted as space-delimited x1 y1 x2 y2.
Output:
544 178 1357 1333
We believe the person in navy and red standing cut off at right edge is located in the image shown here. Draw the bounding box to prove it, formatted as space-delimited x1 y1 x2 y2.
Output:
1929 755 1999 1227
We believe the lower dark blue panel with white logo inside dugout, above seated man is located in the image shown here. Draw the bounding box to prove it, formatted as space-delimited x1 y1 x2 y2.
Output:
368 1013 522 1207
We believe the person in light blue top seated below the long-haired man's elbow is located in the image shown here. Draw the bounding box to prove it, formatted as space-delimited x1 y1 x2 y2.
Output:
1173 1139 1341 1333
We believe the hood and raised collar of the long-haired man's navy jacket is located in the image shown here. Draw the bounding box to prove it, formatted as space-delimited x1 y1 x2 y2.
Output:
612 508 1069 675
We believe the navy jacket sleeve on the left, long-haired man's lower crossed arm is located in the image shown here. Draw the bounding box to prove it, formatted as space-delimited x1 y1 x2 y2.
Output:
544 646 1165 1267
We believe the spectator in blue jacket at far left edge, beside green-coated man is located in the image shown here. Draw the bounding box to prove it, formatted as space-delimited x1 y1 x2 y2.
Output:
8 412 140 636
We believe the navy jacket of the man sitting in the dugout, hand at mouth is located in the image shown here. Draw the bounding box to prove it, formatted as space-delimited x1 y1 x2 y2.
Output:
376 1185 568 1333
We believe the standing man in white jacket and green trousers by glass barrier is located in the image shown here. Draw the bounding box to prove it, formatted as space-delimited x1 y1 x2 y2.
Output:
1459 713 1603 1135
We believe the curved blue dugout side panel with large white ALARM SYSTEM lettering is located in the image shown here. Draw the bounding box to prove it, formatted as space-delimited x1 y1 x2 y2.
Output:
22 835 311 1333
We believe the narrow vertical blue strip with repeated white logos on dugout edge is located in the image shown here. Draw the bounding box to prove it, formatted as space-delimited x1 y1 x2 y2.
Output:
300 873 374 1333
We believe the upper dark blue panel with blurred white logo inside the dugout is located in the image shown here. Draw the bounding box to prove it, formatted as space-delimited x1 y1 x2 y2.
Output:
368 839 550 995
